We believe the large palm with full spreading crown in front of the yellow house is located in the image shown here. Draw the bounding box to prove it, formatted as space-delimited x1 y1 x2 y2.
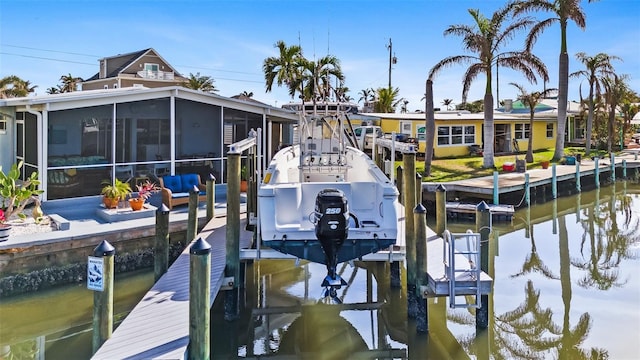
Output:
427 4 549 168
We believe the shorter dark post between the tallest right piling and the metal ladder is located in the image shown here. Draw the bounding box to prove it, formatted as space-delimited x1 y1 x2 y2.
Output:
413 203 429 333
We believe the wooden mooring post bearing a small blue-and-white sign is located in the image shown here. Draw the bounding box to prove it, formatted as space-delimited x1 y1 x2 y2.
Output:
92 240 116 354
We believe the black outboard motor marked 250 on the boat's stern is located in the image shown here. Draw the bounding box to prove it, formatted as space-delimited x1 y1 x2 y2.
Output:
315 189 349 300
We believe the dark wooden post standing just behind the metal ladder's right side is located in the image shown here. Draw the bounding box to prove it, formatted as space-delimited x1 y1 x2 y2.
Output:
476 201 491 329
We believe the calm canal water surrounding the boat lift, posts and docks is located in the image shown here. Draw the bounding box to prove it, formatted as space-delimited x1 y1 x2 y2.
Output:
0 182 640 359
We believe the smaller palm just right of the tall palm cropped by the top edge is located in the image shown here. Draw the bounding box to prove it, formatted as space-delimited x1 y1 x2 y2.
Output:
558 52 620 156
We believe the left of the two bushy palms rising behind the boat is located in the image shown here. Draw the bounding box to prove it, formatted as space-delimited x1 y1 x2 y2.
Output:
262 40 304 99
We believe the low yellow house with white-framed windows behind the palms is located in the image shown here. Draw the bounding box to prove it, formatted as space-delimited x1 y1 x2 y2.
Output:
366 111 557 158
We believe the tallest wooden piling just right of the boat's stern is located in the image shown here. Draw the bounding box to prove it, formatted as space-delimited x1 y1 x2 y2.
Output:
402 154 417 318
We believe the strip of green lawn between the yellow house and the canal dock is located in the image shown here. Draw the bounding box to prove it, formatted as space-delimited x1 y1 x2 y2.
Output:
412 147 604 182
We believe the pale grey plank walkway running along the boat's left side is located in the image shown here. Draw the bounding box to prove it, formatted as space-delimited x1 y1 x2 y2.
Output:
92 214 252 360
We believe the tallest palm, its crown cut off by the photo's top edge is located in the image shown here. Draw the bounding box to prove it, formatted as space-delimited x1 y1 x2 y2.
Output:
514 0 595 160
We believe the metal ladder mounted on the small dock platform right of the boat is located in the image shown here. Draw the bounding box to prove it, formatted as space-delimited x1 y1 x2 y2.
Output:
442 230 481 309
